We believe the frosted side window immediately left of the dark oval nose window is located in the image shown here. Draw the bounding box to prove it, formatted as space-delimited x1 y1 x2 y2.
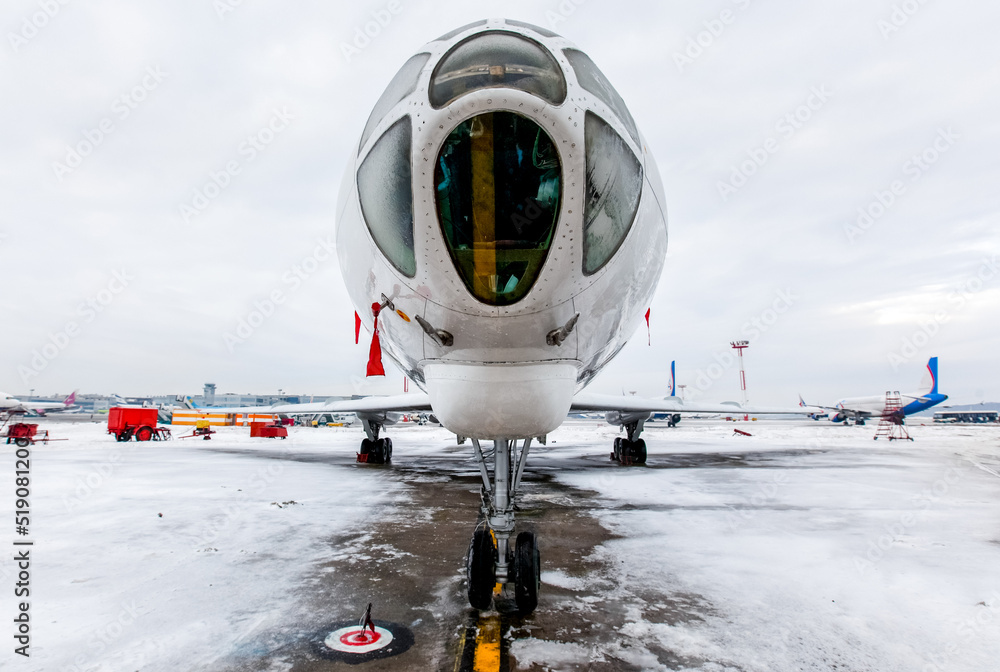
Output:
358 116 417 278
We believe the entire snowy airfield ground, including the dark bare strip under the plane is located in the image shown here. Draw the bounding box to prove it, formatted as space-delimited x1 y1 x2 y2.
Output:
0 419 1000 672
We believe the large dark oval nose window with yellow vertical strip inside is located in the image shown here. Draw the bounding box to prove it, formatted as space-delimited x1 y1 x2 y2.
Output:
434 112 561 306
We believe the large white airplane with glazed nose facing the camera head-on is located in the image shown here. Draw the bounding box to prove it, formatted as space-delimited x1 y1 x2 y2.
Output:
225 19 804 613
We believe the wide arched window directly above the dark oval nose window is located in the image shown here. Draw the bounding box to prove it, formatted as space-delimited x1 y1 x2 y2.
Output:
430 31 566 109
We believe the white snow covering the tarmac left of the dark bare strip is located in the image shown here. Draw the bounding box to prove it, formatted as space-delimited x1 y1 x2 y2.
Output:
0 424 402 672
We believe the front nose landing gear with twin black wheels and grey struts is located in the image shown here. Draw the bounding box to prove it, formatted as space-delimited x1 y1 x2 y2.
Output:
466 439 541 614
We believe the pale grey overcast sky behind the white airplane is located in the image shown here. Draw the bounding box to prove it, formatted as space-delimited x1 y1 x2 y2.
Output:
0 0 1000 403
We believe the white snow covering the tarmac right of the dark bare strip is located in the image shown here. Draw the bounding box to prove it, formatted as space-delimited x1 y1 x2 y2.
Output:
512 422 1000 672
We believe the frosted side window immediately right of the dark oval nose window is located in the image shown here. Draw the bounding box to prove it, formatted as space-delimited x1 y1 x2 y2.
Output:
583 112 642 275
